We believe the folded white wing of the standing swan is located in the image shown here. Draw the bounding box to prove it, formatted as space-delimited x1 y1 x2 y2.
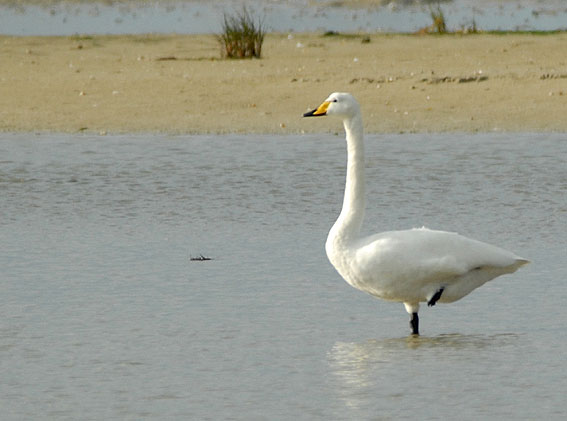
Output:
356 228 526 282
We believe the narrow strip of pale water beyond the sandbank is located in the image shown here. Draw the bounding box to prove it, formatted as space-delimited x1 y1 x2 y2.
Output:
0 0 567 35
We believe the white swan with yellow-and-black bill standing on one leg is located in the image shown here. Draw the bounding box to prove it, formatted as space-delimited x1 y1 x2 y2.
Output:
303 93 528 335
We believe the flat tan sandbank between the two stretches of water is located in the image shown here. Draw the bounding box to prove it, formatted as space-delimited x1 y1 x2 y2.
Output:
0 33 567 134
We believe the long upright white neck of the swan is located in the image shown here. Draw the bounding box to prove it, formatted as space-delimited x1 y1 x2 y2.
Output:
329 113 365 243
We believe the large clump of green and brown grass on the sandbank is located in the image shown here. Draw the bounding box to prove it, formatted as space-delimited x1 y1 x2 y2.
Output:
217 7 266 58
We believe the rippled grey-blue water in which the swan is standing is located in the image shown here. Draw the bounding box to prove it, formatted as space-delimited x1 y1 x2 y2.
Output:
0 133 567 420
